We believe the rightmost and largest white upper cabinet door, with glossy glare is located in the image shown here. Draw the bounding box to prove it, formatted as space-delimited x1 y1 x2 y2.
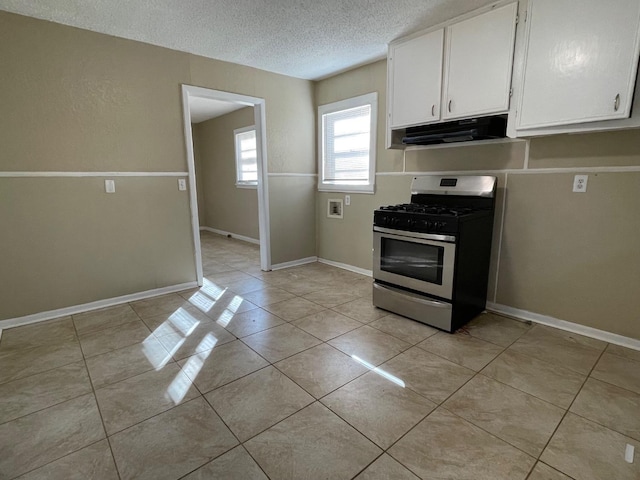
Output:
516 0 640 129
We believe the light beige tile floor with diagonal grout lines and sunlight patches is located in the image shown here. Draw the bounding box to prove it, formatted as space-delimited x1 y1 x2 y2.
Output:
0 233 640 480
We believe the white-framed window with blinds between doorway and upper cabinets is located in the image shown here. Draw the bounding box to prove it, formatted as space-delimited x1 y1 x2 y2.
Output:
318 93 378 193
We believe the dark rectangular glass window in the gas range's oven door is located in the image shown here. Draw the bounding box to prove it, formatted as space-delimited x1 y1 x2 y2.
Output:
380 237 444 285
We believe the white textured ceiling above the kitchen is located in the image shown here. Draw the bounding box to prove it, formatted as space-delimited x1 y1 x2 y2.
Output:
0 0 495 80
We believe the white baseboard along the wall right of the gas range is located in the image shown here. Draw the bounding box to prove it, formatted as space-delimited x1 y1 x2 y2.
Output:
487 302 640 350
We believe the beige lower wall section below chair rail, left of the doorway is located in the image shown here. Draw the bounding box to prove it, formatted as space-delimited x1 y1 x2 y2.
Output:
0 177 195 319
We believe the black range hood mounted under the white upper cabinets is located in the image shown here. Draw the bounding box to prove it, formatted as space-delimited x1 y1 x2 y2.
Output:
402 115 507 145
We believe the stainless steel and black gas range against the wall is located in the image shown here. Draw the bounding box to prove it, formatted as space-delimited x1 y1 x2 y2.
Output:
373 175 497 332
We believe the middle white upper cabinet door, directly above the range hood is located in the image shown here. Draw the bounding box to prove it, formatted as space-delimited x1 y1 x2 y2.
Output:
442 3 518 119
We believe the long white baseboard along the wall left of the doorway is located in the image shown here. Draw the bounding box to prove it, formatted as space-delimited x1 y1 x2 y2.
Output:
0 282 198 332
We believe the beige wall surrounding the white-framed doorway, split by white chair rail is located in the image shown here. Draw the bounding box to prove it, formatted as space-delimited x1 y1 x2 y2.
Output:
0 12 315 320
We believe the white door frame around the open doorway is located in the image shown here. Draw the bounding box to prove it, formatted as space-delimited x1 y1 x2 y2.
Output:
182 84 271 286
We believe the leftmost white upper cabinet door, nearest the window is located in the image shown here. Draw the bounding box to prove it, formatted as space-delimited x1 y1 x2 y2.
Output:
389 29 444 128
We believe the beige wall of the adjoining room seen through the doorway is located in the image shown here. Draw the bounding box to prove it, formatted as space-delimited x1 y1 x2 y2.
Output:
193 107 260 240
